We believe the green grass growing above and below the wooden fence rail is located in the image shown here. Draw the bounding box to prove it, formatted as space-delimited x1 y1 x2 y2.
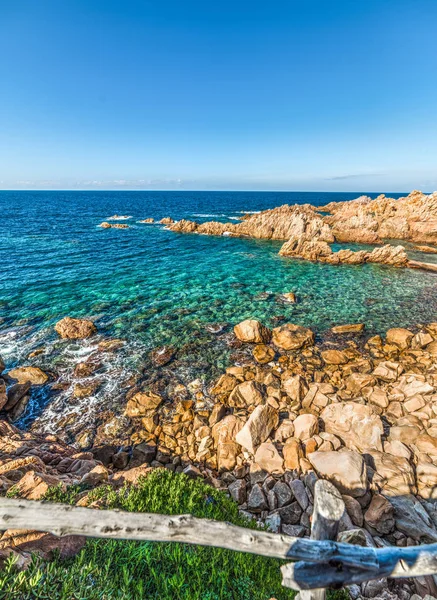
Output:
0 469 346 600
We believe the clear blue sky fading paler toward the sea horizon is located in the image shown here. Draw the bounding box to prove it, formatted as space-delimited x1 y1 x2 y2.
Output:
0 0 437 191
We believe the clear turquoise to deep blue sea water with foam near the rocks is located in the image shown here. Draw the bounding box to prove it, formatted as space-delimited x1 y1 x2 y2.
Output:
0 192 437 432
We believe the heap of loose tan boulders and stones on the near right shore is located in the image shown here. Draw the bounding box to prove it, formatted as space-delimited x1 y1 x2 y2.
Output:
119 320 437 546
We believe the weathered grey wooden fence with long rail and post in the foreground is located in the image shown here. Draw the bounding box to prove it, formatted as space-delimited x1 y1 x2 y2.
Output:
0 480 437 600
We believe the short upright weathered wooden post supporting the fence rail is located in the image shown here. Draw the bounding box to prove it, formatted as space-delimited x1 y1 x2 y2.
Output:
281 479 345 600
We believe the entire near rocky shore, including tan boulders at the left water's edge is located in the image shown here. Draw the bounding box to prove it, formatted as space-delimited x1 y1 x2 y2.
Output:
0 318 437 598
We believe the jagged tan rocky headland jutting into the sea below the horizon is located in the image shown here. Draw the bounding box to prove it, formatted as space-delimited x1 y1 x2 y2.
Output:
168 191 437 270
